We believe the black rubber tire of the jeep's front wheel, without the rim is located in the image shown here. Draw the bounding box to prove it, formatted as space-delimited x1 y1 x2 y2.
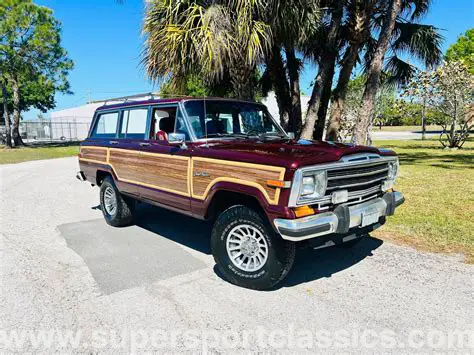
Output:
211 205 295 290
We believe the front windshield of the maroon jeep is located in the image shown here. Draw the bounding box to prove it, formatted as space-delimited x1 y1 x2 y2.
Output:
184 100 286 139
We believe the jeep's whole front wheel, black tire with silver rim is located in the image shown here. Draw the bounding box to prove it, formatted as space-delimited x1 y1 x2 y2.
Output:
211 205 295 290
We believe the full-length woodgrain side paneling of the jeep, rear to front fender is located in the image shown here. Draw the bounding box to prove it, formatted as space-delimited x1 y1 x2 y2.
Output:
80 147 285 205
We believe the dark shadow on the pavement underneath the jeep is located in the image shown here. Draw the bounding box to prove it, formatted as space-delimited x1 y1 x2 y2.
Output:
131 203 383 290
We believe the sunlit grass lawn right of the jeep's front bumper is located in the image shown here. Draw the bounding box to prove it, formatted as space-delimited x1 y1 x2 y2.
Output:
373 140 474 263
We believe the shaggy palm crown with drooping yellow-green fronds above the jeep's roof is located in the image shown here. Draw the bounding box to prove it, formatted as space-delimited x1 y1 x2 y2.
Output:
142 0 271 99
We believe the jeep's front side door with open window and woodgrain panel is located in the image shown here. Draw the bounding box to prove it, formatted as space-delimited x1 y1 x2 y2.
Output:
136 104 191 212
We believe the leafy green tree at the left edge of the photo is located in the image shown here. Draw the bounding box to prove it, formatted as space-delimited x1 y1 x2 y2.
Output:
0 0 73 146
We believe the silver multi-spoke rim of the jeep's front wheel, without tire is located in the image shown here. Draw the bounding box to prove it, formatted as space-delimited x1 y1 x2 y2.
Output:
226 224 268 272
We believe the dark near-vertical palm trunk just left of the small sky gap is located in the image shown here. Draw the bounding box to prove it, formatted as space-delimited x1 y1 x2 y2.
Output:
285 47 303 137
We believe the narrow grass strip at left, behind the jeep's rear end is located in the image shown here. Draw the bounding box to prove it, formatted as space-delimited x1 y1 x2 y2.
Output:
0 145 79 164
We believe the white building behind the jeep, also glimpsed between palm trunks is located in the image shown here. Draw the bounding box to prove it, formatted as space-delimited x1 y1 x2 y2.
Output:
51 92 310 140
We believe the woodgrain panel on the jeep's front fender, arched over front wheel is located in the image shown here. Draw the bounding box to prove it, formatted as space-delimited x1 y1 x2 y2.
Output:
192 158 285 204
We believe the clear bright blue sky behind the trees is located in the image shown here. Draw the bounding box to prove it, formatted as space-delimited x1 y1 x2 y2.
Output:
24 0 474 119
